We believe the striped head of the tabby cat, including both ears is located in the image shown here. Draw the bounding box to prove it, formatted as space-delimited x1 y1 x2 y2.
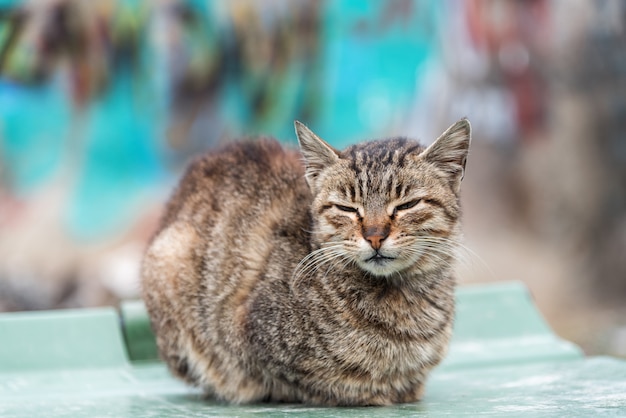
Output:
296 119 471 277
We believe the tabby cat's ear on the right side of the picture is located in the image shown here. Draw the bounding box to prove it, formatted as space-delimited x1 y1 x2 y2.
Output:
420 118 472 193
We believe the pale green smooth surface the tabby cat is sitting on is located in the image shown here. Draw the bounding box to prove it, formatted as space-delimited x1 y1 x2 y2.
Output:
0 283 626 417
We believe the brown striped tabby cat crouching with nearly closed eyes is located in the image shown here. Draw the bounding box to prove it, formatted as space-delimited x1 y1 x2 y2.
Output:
142 119 471 406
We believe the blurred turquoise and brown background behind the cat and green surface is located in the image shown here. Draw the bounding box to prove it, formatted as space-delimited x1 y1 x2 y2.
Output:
0 0 626 356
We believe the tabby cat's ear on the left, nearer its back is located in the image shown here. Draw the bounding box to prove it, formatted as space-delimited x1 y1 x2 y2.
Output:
294 121 339 189
